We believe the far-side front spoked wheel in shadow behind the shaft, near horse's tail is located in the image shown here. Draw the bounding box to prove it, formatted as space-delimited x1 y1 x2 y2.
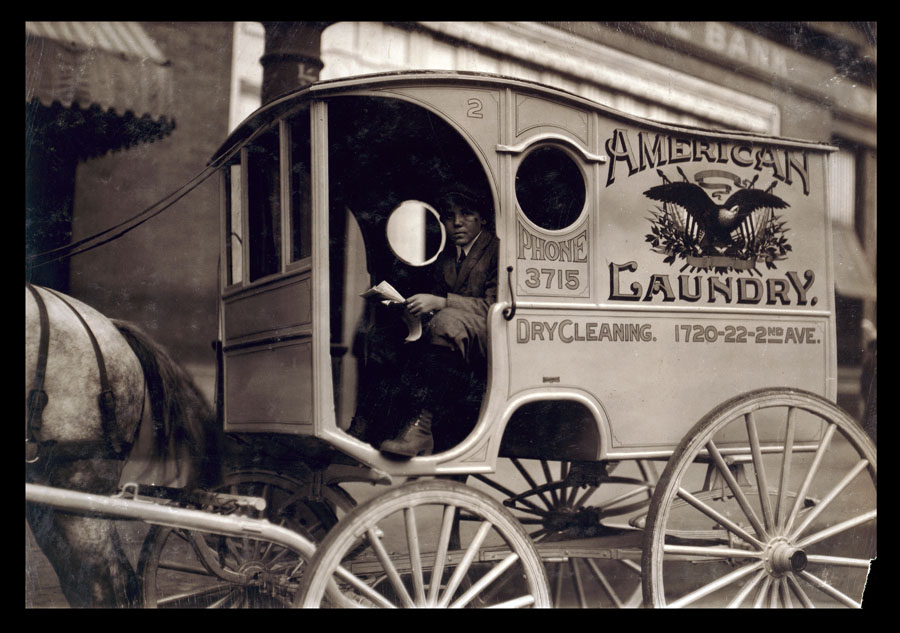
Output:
138 471 353 608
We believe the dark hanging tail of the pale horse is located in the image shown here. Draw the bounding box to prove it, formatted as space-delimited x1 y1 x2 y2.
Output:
111 319 223 487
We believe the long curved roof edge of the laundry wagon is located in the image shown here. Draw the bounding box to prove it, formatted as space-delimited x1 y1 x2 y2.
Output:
210 70 836 164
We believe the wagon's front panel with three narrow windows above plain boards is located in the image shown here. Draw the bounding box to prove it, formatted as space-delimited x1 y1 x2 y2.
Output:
220 104 327 433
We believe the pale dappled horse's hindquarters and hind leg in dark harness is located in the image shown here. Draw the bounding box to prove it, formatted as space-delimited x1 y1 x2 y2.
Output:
25 283 222 608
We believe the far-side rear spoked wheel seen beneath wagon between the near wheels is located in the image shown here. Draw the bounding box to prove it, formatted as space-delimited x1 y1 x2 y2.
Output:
473 458 658 608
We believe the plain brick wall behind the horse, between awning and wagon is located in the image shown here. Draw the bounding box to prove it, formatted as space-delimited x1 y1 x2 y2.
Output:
71 22 232 380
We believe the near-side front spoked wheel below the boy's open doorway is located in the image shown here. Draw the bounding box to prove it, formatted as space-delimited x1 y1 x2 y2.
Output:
300 480 550 608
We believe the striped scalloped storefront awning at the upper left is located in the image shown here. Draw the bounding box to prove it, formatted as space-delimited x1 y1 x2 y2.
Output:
25 22 175 156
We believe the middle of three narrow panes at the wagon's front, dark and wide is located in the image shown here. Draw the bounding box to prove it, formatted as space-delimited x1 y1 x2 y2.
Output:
247 130 281 281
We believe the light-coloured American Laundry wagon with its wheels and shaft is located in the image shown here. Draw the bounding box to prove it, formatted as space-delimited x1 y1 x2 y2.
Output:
26 72 876 607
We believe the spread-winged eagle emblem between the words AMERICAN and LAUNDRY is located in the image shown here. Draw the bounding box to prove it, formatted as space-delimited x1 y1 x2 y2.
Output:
644 168 791 274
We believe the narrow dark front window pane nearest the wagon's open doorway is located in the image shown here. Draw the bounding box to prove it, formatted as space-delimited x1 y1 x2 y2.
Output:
290 110 312 262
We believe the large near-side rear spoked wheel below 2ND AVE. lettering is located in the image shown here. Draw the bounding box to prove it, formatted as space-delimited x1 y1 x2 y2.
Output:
643 389 876 607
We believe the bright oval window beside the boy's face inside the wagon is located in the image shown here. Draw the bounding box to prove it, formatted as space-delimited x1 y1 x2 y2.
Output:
386 200 447 266
